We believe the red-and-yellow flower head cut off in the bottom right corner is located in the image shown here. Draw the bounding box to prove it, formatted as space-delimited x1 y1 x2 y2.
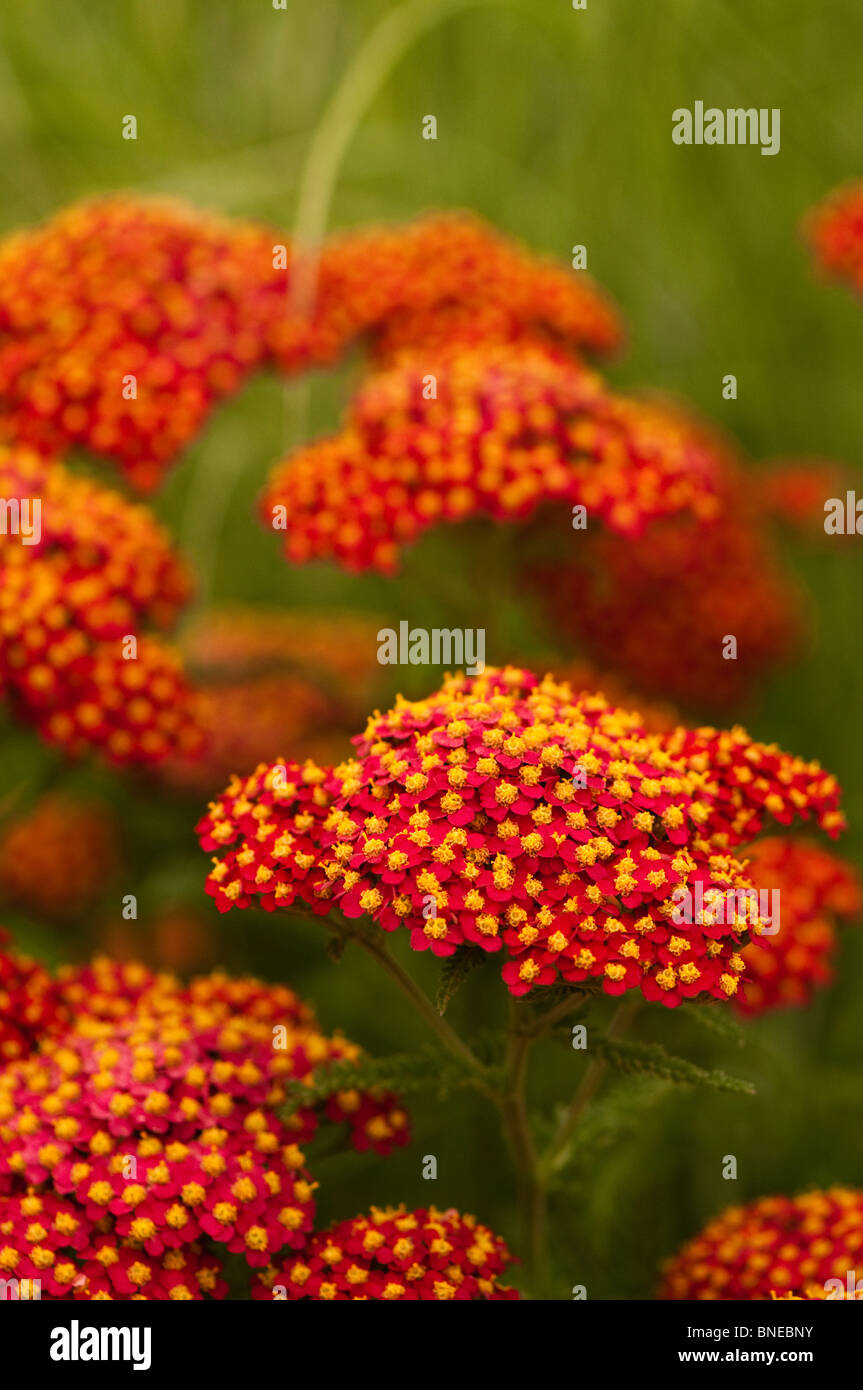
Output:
659 1187 863 1300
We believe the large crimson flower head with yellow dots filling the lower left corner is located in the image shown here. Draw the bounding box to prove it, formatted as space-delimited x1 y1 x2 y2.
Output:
0 962 407 1300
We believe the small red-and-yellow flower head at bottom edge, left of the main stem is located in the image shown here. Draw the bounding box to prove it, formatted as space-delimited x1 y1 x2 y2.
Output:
253 1205 518 1302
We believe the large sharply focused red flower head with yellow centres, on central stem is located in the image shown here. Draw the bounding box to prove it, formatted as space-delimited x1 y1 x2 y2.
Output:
197 669 842 1006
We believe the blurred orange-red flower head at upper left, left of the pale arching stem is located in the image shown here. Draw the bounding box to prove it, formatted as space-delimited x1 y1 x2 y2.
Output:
0 196 285 491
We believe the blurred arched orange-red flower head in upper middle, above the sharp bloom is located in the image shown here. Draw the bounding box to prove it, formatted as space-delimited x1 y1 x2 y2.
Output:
261 343 718 571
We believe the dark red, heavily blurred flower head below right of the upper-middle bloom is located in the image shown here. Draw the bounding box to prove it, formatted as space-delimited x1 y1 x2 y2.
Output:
532 489 805 709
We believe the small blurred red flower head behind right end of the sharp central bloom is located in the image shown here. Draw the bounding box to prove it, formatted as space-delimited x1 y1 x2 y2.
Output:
735 835 862 1015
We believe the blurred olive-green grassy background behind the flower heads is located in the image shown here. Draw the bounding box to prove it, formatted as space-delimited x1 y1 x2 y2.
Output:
0 0 863 1298
